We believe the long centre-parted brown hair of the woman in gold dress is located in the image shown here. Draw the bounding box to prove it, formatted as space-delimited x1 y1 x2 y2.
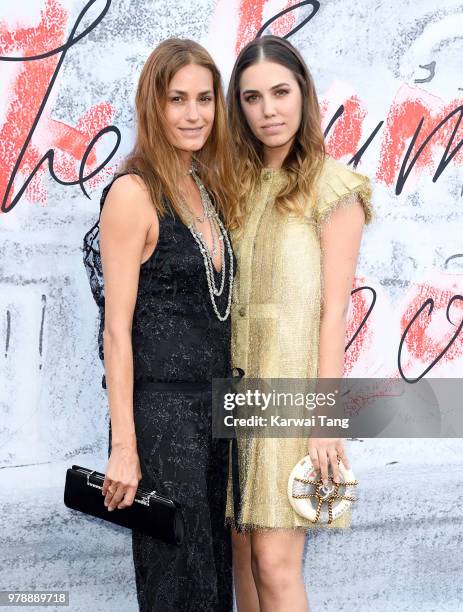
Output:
227 36 325 226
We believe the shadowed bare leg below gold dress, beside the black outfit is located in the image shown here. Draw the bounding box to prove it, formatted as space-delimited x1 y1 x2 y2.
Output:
231 529 260 612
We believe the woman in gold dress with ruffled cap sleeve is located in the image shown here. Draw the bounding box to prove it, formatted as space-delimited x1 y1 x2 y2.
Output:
227 36 373 612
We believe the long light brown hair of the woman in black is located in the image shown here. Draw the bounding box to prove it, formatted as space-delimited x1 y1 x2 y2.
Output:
119 38 241 227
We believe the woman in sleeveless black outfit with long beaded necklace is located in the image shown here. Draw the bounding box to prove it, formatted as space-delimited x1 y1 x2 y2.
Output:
84 39 236 612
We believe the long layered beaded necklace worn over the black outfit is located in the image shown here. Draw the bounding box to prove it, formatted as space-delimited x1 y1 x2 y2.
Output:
184 165 233 321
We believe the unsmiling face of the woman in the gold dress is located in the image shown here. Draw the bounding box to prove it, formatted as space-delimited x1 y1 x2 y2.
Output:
240 60 302 161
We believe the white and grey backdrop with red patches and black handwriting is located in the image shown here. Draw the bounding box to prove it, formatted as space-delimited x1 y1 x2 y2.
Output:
0 0 463 611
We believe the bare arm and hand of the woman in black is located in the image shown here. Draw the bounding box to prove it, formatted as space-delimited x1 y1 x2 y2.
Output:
100 175 159 508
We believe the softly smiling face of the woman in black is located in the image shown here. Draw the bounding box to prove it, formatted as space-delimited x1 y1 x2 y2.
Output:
164 64 215 156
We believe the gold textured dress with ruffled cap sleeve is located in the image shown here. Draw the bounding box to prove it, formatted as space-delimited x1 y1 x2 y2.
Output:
226 157 373 530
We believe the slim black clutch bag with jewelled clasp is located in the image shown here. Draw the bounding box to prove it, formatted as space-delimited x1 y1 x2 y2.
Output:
64 465 185 544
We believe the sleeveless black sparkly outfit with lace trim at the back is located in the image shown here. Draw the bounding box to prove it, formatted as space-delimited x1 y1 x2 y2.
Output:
84 177 236 612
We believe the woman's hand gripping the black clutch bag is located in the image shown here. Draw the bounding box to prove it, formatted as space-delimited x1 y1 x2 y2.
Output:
102 445 141 511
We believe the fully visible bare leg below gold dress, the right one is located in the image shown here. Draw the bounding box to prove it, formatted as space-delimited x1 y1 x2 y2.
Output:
248 529 309 612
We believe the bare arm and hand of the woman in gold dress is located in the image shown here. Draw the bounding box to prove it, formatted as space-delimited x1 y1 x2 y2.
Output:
309 196 365 488
